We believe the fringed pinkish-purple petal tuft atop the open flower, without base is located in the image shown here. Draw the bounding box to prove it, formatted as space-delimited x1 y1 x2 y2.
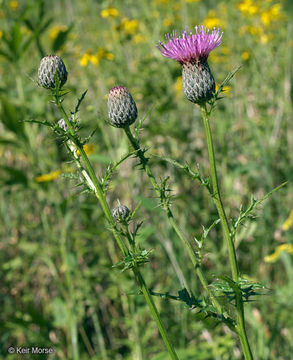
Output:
157 26 223 63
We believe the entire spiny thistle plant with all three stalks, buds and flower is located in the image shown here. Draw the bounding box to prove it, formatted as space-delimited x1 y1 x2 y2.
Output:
35 26 284 360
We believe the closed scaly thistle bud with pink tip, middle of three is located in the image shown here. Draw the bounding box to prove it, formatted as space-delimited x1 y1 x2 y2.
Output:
108 86 137 128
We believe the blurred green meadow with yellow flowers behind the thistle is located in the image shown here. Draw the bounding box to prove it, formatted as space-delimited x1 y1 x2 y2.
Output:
0 0 293 360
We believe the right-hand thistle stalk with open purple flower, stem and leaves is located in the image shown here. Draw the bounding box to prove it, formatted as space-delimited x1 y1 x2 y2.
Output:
157 26 283 360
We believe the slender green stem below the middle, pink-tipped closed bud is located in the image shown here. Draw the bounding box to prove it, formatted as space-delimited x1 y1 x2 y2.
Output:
124 126 222 314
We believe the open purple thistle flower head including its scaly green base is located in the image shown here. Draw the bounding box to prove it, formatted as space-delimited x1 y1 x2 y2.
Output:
157 26 223 104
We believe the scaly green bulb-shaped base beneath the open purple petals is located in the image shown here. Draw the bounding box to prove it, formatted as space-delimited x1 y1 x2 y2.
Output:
182 59 215 104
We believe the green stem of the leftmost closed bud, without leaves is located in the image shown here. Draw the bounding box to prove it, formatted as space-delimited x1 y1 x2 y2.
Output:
55 96 179 360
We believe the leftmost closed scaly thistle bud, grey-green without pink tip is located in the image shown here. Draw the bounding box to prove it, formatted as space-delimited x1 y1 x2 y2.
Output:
38 55 67 89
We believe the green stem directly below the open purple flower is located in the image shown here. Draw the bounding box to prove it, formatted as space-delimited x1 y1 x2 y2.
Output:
201 105 253 360
